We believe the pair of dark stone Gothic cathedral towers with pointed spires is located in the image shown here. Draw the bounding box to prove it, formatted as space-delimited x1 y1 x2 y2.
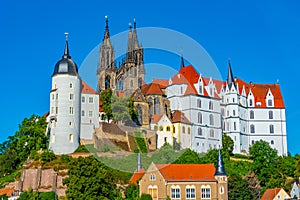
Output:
97 17 145 96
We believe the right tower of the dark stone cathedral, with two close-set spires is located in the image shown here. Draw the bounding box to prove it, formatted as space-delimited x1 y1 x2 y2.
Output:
123 20 145 96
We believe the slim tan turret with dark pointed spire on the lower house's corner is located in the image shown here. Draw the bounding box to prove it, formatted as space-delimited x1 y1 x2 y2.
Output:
215 149 228 200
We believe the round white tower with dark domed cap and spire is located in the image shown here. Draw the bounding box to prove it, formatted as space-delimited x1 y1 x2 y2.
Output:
49 38 81 154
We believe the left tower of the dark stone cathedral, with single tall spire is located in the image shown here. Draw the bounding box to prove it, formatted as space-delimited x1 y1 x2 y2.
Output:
97 16 116 92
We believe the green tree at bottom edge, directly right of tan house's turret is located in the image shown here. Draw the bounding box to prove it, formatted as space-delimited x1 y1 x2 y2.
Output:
228 174 254 200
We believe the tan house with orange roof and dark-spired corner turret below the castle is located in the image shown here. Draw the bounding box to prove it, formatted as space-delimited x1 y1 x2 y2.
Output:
130 152 228 200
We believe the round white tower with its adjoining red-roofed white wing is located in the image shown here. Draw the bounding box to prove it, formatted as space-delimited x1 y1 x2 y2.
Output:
47 41 99 154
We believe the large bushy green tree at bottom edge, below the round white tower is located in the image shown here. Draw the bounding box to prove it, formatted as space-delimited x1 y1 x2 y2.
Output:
63 156 122 200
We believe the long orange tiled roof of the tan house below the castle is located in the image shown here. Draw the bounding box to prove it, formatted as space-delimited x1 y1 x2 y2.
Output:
156 164 216 181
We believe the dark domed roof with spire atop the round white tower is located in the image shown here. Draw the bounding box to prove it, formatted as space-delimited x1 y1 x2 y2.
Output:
52 41 78 76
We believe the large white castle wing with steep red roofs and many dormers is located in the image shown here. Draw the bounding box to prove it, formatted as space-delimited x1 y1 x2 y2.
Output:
166 60 287 155
